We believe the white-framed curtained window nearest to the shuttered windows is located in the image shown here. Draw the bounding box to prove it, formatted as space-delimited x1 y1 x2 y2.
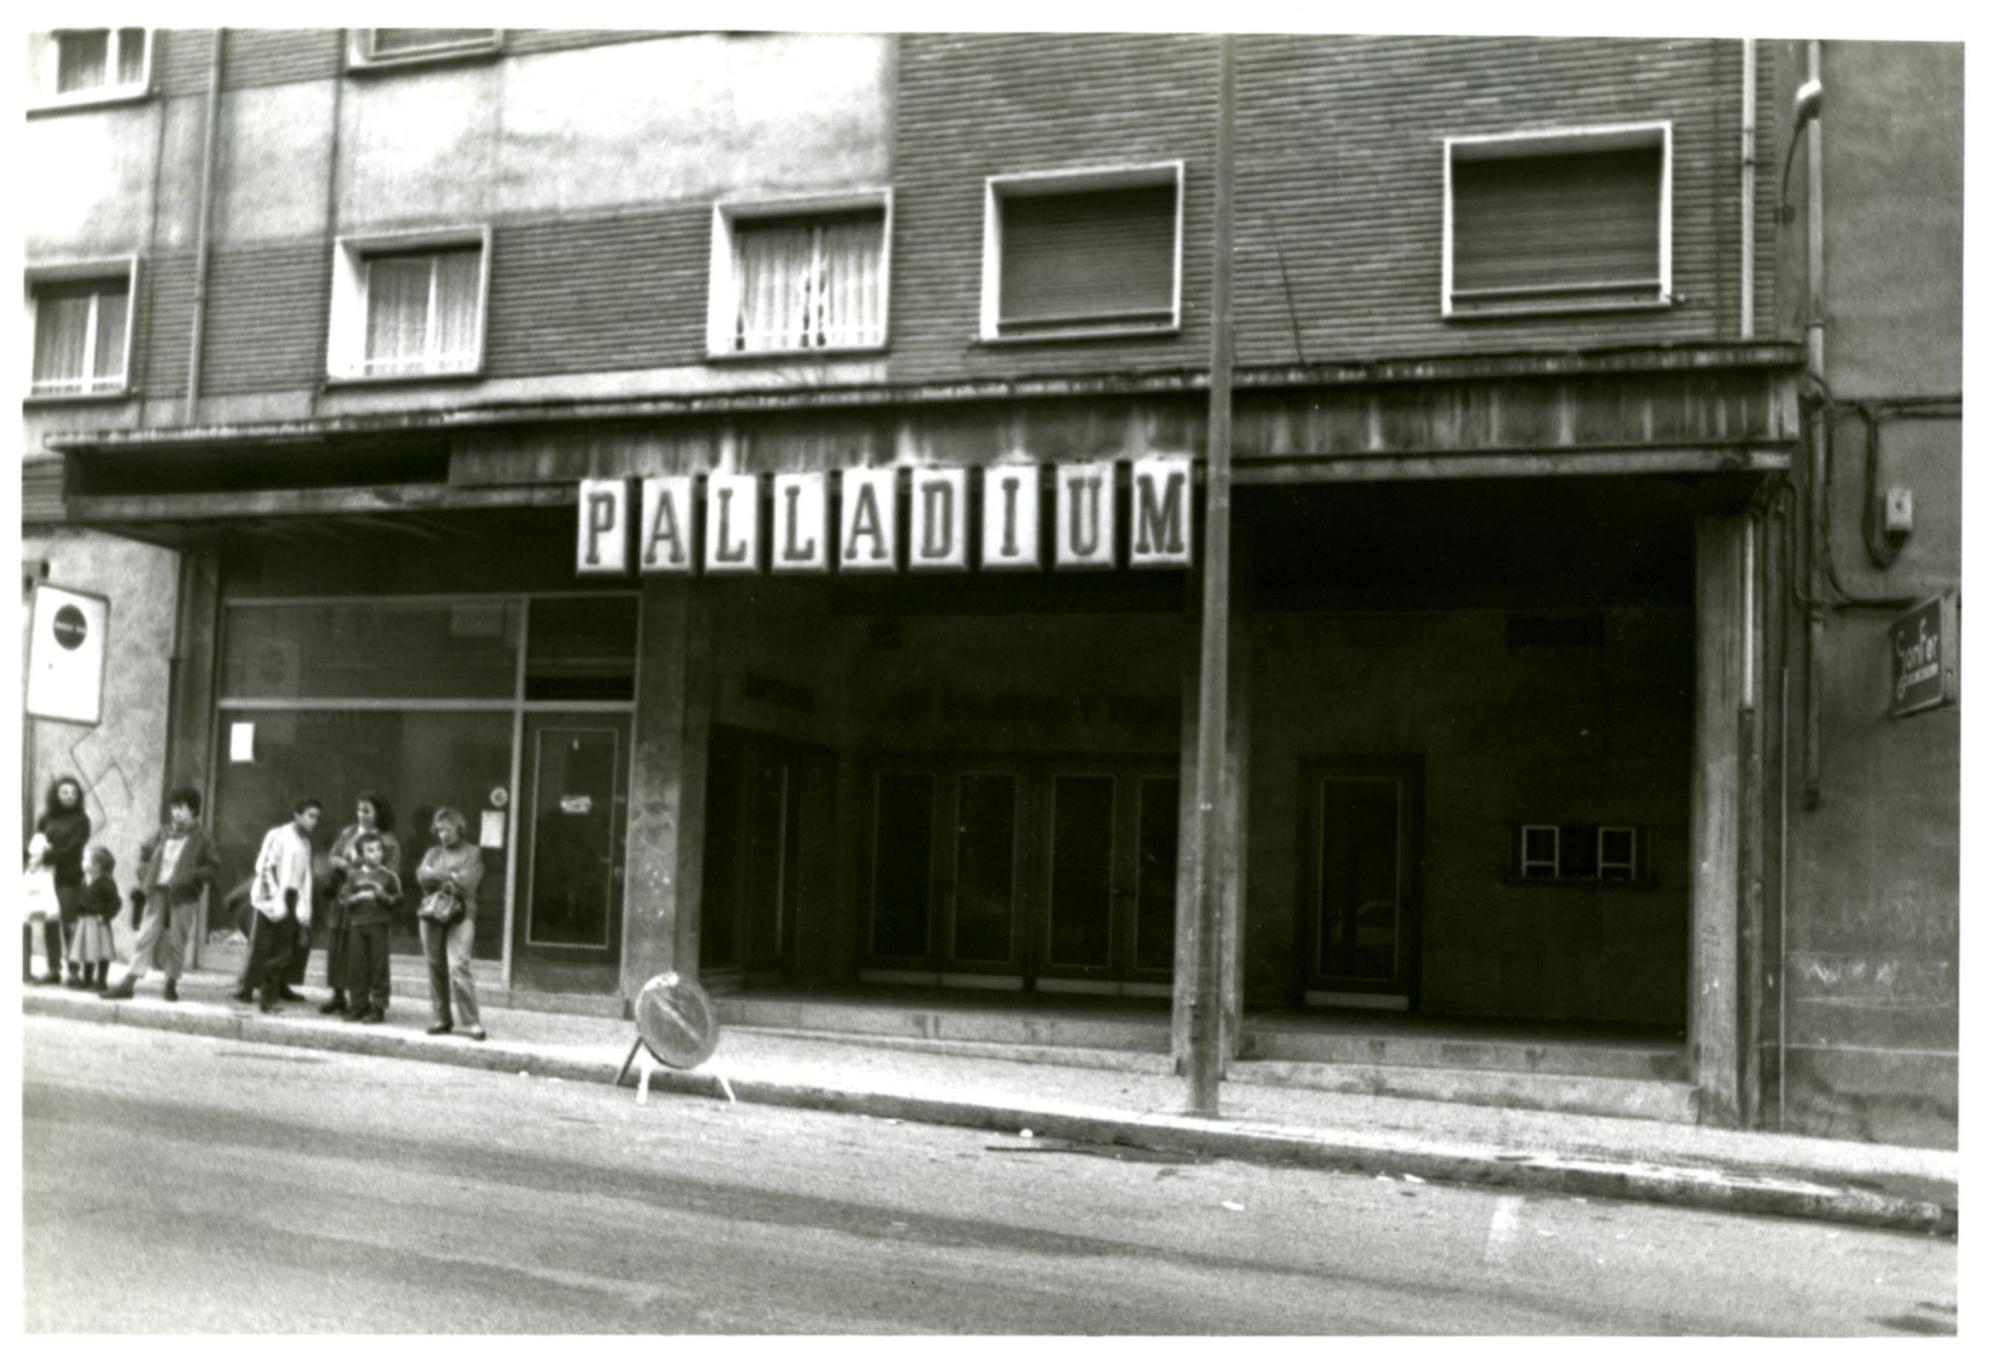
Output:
708 194 888 354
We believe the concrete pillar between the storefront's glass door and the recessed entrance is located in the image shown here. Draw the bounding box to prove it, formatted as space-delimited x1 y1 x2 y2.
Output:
620 580 714 998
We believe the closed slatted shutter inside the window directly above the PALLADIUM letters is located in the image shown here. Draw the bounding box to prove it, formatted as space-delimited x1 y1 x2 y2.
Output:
1000 184 1178 326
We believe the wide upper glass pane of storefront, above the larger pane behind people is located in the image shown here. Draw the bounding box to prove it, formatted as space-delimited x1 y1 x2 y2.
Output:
222 600 522 698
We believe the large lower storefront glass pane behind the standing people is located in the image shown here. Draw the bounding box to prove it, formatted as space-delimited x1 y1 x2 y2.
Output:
210 710 514 960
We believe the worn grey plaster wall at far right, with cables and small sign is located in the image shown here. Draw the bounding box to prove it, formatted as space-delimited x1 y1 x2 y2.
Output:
1762 42 1952 1146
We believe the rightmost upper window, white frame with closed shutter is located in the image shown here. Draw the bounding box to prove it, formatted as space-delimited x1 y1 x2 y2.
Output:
1444 122 1674 316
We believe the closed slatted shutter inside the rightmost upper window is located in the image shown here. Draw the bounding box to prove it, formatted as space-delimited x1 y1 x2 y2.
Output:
1452 146 1660 294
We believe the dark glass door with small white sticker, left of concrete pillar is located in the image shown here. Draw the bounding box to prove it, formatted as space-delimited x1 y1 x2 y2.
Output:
514 712 632 990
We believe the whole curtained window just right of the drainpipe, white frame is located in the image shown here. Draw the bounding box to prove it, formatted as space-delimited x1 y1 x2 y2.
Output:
326 228 490 380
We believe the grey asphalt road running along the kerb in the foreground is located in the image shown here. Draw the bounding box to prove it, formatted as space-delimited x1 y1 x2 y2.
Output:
11 1018 1958 1336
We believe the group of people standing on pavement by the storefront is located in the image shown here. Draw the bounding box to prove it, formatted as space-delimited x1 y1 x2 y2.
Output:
22 776 486 1040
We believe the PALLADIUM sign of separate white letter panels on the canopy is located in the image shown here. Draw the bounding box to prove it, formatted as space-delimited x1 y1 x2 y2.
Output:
576 456 1194 576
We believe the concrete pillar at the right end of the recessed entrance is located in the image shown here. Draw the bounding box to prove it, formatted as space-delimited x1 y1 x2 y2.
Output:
1688 514 1756 1126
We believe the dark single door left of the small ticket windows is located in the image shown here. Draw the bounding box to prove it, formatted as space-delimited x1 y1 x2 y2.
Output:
1298 760 1422 1010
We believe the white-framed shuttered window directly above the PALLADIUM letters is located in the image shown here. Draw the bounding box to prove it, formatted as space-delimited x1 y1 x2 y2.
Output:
980 162 1182 340
